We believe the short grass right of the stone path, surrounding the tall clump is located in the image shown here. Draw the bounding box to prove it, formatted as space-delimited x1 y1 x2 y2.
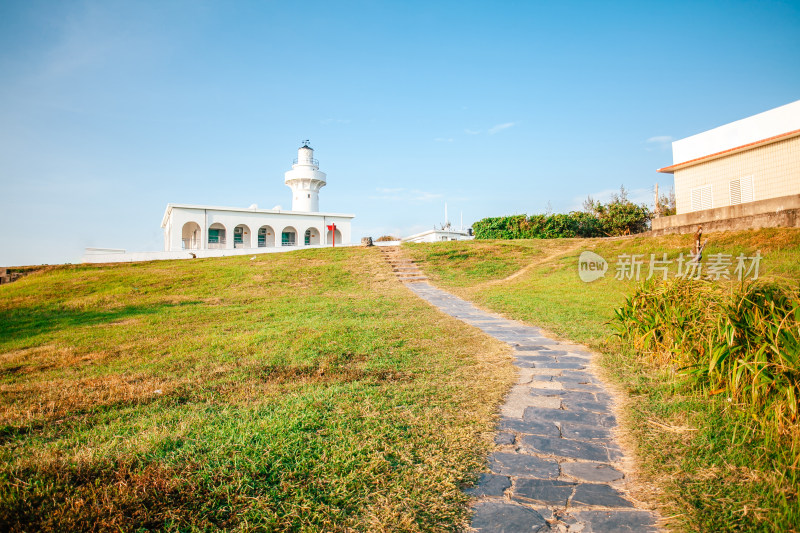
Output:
411 229 800 531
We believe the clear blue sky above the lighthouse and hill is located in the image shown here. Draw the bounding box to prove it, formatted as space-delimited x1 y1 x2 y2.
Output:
0 0 800 265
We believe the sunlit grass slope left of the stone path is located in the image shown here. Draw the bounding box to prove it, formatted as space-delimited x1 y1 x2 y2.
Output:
0 248 513 531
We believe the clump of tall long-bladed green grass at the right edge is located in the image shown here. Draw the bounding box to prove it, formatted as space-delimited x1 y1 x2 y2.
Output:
612 278 800 456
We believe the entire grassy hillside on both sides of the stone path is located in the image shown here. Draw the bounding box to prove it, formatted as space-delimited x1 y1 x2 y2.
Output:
0 230 800 531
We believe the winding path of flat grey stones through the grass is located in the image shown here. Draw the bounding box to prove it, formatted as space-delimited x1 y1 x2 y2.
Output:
407 282 658 533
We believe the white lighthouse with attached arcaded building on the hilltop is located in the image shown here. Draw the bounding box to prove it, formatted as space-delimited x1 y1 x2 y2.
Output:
161 141 355 255
